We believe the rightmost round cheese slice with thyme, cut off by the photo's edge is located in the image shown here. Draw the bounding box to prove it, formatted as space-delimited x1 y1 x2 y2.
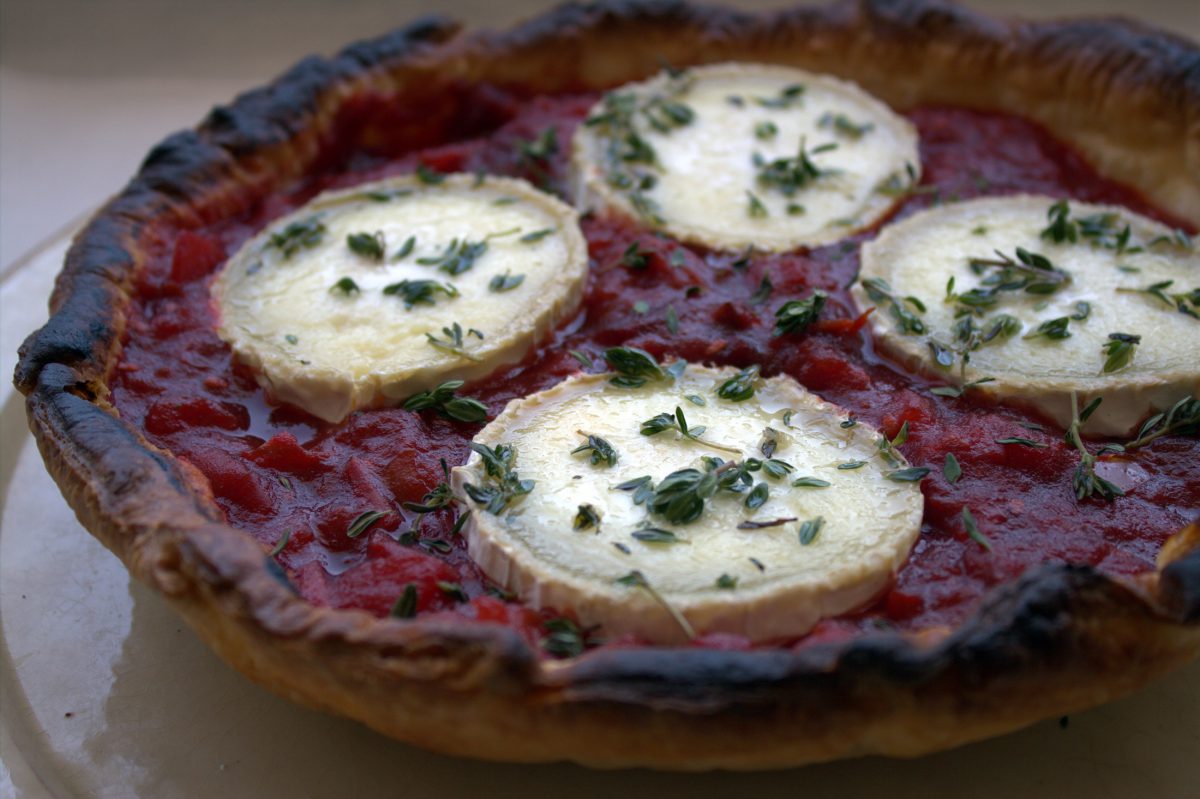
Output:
853 196 1200 435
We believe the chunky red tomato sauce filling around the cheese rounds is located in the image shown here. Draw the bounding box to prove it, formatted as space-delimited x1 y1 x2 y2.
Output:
112 90 1200 648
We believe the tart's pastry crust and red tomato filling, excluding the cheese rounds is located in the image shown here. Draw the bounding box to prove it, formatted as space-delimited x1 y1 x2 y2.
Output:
16 2 1200 769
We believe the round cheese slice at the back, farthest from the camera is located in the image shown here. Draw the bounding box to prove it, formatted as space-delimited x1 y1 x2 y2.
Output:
572 64 920 252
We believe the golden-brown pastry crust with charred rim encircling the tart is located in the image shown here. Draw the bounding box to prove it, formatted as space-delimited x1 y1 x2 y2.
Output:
16 0 1200 769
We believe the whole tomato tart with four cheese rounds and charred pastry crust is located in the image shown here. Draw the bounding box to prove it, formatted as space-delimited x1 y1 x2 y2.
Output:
16 0 1200 769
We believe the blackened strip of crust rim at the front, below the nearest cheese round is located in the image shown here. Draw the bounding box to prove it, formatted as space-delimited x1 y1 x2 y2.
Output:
556 565 1151 714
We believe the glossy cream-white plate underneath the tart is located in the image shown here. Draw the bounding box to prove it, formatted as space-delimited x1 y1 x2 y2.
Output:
0 229 1200 799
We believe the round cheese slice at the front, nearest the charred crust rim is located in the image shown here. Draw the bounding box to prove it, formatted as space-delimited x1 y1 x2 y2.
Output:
452 366 923 643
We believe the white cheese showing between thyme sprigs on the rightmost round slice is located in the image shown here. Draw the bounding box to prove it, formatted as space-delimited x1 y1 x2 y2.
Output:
853 197 1200 435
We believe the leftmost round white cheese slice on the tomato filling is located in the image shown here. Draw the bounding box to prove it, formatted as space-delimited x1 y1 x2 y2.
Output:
212 175 587 421
